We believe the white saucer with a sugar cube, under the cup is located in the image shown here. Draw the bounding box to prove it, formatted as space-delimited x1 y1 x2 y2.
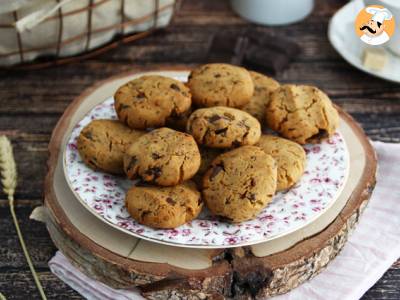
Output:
328 0 400 83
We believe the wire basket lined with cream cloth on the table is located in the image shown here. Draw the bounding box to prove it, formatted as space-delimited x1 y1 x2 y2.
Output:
0 0 180 68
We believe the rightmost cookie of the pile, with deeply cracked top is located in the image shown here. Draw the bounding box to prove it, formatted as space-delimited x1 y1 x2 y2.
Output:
265 84 339 144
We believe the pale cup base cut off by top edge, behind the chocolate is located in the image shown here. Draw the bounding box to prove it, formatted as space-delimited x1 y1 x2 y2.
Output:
231 0 314 25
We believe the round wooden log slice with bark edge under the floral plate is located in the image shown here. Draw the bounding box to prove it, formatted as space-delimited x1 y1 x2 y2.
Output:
41 68 376 299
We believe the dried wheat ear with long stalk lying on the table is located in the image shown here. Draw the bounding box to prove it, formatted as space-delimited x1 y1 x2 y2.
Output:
0 135 47 299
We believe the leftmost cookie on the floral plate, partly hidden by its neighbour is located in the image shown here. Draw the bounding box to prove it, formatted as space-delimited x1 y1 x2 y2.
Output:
77 120 146 174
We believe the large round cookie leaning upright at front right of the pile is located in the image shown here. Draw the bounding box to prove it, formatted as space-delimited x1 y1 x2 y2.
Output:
202 146 277 222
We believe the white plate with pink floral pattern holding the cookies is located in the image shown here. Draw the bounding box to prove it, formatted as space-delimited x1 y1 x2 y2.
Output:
64 98 349 248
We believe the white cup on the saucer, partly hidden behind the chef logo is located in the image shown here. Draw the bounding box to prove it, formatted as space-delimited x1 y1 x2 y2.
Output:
364 0 400 56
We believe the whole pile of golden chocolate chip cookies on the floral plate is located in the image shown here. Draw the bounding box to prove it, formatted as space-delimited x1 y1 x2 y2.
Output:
78 64 339 228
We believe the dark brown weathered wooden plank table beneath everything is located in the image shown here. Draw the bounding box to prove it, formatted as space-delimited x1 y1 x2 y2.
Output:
0 0 400 299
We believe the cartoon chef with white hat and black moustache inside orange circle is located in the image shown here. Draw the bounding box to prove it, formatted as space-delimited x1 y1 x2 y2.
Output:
360 7 392 45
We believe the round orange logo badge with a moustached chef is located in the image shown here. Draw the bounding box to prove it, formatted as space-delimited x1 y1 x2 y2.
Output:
354 5 396 46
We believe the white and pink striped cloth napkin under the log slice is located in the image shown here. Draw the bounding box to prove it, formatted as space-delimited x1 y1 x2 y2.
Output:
49 142 400 300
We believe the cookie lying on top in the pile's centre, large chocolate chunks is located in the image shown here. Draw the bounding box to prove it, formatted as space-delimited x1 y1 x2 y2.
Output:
186 106 261 148
